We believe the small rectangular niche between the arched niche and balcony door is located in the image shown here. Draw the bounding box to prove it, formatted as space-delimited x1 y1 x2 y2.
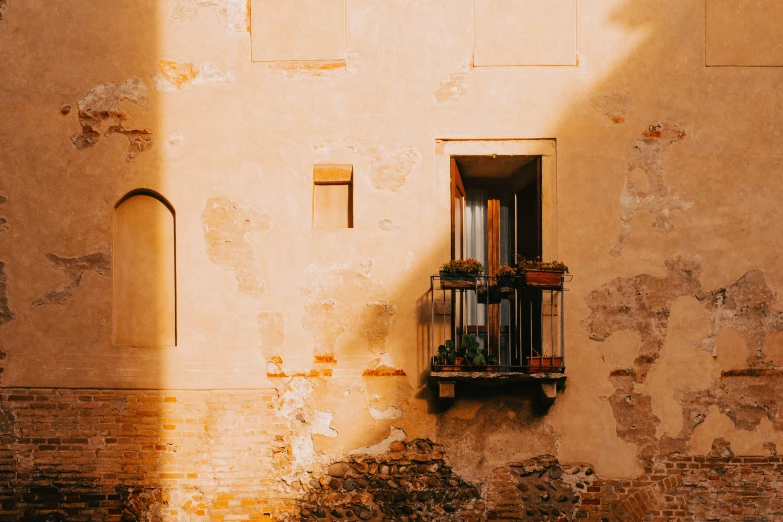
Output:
313 165 353 229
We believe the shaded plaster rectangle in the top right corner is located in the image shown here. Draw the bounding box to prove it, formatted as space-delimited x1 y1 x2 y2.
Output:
706 0 783 67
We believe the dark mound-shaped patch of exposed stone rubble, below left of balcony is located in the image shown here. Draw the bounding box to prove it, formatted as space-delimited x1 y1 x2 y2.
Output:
299 439 485 522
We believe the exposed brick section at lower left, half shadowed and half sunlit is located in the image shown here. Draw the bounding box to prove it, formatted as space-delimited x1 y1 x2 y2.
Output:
0 389 295 522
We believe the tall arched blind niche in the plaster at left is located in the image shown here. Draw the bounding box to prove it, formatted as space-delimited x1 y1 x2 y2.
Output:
112 190 177 346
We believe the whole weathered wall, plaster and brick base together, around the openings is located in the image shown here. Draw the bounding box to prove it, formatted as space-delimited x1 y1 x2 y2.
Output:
0 0 783 521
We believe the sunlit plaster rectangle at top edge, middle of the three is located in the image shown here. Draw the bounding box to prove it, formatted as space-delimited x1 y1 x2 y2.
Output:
473 0 576 67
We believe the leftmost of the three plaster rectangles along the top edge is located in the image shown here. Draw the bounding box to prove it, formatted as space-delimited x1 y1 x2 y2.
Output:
250 0 345 62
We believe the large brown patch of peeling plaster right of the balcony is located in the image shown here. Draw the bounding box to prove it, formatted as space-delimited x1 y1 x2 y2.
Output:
583 256 783 459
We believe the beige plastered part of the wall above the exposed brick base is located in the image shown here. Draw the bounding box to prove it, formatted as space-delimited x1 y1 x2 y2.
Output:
0 0 783 477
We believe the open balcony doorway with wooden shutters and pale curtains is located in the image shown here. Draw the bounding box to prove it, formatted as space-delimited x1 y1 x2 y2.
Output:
451 155 554 365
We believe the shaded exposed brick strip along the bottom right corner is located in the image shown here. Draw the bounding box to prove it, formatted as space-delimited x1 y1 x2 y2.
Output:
487 452 783 522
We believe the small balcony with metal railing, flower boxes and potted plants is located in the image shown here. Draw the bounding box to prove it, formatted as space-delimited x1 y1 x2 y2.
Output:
428 273 569 406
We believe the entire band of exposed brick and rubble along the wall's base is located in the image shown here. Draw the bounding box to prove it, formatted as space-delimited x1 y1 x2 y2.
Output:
0 389 783 522
